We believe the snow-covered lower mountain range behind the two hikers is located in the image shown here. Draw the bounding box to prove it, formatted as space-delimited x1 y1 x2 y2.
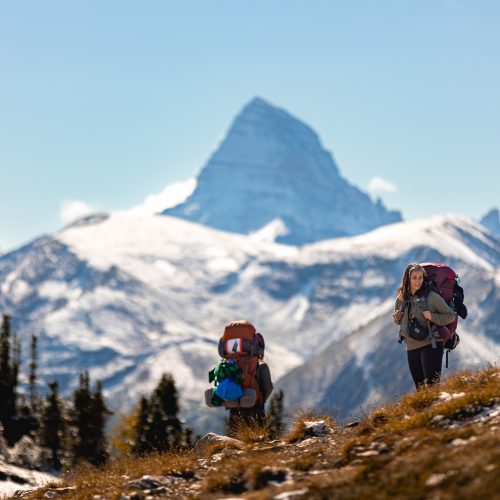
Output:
0 213 500 431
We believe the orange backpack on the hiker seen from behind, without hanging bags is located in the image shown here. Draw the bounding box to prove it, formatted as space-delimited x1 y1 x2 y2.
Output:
219 320 265 404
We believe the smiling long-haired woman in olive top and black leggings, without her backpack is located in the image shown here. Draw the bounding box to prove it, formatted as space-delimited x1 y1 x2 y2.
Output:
393 264 455 389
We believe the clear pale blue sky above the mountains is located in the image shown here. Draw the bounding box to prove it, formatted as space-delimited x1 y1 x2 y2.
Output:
0 0 500 250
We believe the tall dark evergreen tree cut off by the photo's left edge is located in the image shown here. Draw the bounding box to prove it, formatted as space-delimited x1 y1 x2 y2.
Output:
0 314 20 441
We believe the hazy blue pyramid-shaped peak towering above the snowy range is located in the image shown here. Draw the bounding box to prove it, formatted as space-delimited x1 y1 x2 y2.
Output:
164 98 401 245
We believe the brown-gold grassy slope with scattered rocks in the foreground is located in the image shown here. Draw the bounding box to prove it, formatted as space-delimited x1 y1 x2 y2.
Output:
24 368 500 500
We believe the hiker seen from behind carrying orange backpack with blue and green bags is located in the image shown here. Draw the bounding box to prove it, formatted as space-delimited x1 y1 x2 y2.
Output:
209 320 273 431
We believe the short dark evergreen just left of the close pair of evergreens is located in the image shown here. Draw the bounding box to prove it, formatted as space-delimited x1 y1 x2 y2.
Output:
40 382 66 470
